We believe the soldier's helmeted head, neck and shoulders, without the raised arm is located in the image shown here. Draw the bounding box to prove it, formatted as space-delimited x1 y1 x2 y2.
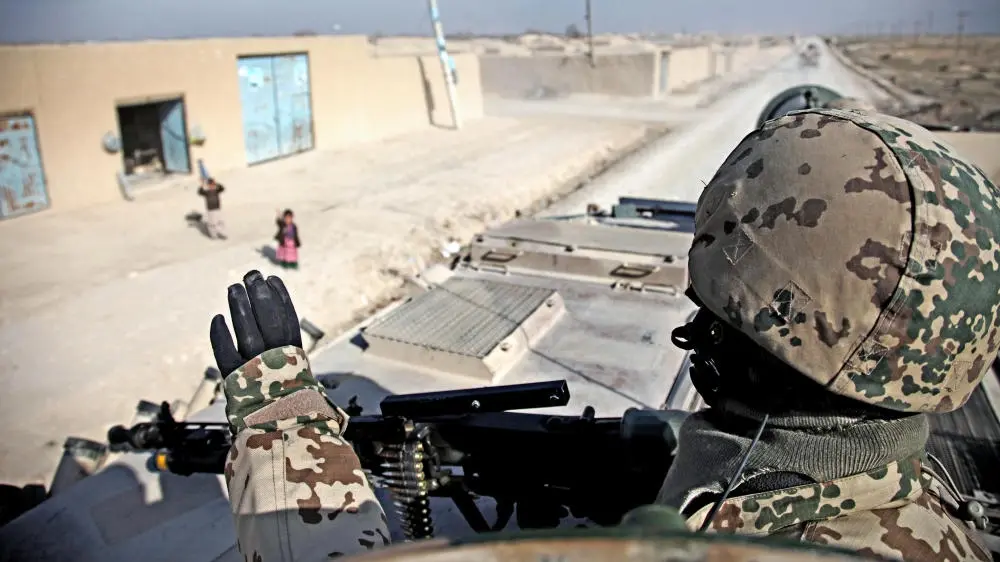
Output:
658 109 1000 561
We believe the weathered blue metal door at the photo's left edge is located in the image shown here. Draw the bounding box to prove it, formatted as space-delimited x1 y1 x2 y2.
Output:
0 115 49 218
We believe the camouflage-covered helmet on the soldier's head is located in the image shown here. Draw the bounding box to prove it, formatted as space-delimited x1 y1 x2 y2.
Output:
689 109 1000 412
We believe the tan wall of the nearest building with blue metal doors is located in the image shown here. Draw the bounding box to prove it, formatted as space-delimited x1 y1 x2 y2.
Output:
0 36 482 209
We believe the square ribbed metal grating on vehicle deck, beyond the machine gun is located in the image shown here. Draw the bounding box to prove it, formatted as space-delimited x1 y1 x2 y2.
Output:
365 278 555 359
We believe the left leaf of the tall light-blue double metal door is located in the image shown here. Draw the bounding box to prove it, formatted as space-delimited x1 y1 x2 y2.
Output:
237 57 281 164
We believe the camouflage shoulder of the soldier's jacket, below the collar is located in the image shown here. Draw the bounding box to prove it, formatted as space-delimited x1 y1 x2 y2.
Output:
803 484 992 562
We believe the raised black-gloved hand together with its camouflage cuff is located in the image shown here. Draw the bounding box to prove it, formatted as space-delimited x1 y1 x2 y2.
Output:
209 271 347 435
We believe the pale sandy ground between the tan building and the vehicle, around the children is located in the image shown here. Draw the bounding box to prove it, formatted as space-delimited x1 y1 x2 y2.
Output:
0 118 649 484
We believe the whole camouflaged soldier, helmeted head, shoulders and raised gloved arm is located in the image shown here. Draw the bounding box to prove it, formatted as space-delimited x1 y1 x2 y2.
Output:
211 109 1000 562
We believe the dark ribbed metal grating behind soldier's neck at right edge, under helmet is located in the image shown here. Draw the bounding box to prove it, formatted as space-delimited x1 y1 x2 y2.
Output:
927 382 1000 496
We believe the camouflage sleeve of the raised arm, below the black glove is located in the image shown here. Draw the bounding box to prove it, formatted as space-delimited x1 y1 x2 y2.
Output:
223 346 389 562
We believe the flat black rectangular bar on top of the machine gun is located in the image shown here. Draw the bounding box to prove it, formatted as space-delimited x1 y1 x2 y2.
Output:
381 380 569 418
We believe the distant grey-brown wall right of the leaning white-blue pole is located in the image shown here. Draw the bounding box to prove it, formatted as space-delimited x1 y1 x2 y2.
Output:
479 52 657 98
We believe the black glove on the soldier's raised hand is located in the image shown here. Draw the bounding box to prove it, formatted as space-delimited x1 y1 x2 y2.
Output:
209 270 302 377
